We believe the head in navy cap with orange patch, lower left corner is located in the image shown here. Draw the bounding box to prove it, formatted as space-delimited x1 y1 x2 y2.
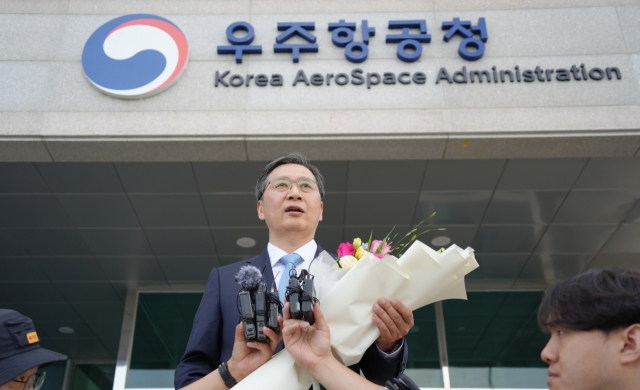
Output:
0 309 67 390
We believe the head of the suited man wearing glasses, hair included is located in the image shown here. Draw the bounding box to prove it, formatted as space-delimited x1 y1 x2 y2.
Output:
255 153 324 241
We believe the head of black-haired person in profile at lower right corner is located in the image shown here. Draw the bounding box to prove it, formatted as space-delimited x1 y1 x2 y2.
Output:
538 268 640 390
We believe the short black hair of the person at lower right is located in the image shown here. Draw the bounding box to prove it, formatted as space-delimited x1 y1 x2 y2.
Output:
538 268 640 334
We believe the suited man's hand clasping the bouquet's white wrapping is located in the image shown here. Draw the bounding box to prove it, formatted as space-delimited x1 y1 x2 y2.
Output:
373 297 413 353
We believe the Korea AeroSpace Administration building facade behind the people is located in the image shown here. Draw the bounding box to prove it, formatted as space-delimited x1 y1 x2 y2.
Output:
0 0 640 390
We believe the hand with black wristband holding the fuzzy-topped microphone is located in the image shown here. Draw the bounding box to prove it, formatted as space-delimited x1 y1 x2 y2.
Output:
227 316 282 382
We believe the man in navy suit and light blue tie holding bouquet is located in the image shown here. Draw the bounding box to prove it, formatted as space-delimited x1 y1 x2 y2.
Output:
175 153 413 390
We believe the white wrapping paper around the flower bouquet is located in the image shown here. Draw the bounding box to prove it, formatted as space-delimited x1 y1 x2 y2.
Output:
235 241 478 390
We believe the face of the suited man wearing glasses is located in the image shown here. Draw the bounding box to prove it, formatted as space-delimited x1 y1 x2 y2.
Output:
258 164 324 235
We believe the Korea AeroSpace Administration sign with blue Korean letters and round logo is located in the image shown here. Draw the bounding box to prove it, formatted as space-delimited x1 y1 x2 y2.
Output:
82 14 622 99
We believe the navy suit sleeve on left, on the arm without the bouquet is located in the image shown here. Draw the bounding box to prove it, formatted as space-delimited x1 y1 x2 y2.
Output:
174 268 222 389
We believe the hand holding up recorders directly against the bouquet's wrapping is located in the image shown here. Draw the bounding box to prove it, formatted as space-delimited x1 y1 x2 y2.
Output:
282 302 333 374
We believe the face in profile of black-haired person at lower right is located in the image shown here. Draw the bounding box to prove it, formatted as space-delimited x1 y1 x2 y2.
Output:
540 326 620 390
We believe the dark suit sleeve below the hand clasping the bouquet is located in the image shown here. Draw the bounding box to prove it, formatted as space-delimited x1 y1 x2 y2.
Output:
358 340 409 386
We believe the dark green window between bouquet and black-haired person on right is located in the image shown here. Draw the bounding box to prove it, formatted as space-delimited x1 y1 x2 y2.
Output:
443 292 548 388
